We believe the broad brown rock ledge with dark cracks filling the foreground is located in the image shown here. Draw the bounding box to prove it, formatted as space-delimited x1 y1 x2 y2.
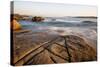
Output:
13 33 97 65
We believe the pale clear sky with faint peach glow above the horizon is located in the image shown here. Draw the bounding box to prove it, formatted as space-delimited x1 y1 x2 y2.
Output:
14 1 97 17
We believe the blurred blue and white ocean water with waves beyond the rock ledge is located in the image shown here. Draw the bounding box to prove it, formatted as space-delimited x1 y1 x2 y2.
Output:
20 17 97 44
